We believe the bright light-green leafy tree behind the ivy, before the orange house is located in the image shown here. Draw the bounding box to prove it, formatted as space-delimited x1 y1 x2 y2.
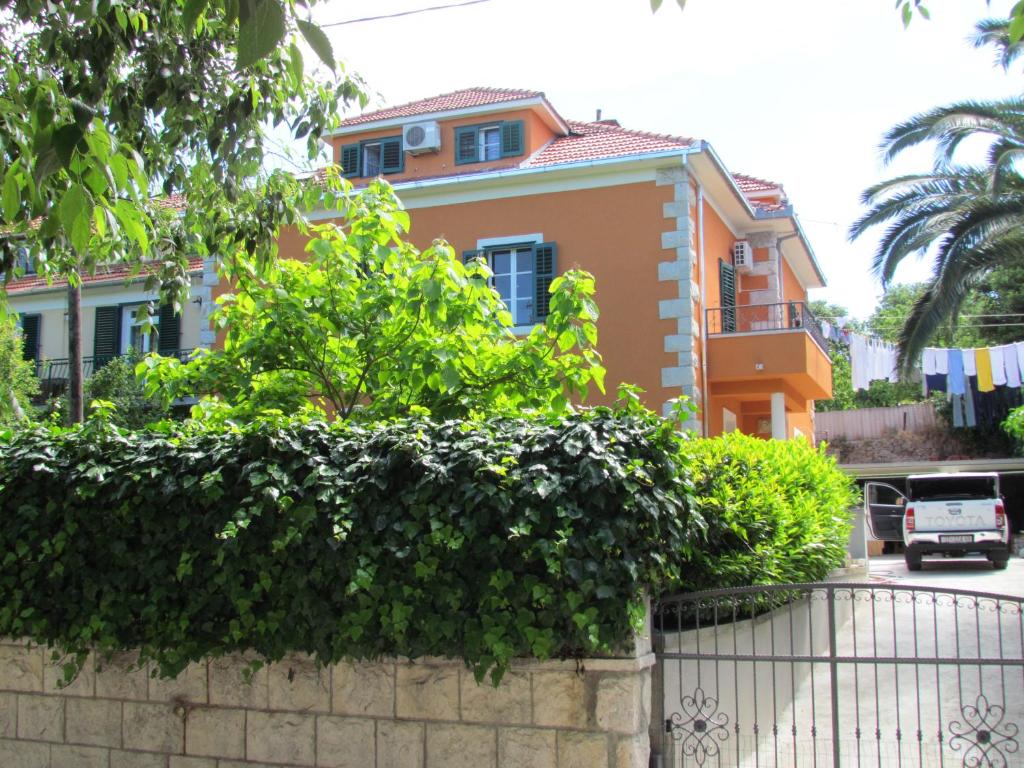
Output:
139 180 604 428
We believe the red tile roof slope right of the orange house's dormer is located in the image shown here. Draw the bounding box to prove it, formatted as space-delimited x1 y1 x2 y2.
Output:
522 120 693 168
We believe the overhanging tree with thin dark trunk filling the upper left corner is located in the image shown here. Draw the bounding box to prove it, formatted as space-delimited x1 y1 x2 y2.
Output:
0 0 365 419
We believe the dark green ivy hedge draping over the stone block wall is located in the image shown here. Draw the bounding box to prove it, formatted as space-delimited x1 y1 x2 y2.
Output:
0 409 700 679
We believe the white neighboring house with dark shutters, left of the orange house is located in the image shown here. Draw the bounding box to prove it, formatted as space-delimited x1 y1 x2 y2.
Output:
6 259 217 395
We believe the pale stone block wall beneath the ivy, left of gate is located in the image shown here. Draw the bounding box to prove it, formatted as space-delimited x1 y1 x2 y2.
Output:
0 640 653 768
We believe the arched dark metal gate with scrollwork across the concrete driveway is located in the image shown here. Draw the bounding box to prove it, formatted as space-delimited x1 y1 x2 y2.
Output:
652 583 1024 768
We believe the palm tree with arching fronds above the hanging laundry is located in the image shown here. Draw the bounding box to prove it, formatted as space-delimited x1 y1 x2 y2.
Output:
850 15 1024 371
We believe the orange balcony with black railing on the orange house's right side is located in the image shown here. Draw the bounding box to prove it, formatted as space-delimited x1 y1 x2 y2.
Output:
706 301 831 411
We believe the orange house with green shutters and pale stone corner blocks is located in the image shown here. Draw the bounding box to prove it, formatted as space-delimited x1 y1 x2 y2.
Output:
292 88 831 438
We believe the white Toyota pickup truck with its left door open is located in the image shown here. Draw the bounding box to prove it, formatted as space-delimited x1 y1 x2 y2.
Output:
864 472 1011 570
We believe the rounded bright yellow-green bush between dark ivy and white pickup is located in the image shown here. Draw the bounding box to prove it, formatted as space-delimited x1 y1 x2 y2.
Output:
682 432 857 591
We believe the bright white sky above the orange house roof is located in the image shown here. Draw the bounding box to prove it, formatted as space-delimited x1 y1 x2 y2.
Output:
299 0 1020 317
